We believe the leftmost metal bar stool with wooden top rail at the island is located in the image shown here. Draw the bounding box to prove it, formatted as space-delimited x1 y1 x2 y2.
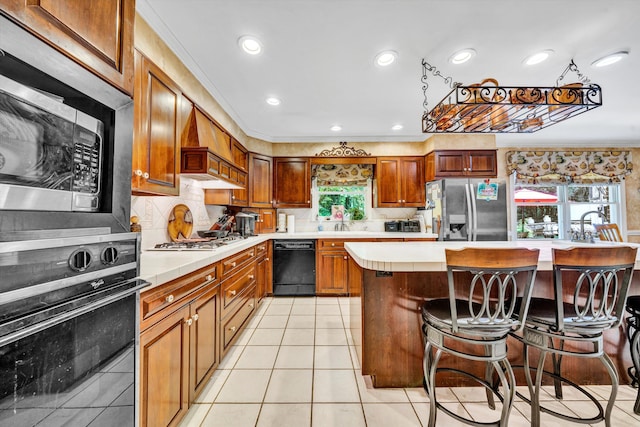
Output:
422 248 539 427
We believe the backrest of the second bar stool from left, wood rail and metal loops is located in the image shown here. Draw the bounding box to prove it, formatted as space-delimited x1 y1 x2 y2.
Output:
553 246 637 333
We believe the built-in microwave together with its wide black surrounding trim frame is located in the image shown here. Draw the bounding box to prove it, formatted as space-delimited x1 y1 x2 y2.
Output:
0 14 133 234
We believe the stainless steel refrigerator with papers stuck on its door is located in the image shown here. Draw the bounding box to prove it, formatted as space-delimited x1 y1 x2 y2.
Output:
427 178 508 241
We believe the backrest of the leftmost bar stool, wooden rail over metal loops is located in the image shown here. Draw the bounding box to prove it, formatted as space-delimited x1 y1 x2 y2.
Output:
445 248 539 335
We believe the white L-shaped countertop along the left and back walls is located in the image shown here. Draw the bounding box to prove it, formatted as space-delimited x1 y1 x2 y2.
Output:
140 231 437 292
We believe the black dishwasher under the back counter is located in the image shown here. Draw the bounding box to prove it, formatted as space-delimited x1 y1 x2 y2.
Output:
273 239 316 296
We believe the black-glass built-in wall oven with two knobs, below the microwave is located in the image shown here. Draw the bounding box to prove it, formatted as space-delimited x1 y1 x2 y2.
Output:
0 228 148 427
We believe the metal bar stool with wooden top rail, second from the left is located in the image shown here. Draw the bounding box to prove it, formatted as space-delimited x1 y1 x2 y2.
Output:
516 246 637 427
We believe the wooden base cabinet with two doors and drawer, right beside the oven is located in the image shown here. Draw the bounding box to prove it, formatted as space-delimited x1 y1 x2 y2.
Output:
140 263 220 427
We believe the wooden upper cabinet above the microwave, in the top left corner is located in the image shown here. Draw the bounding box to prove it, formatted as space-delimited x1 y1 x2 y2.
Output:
2 0 135 96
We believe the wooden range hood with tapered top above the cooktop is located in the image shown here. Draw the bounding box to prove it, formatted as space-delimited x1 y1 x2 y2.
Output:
180 107 246 190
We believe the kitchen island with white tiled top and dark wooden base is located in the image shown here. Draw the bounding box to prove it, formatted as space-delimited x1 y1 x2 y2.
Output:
345 240 640 387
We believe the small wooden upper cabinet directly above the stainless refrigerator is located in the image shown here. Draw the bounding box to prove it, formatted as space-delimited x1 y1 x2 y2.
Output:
426 150 498 181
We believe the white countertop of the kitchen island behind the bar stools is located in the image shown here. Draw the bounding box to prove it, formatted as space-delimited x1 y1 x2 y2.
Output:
345 240 640 272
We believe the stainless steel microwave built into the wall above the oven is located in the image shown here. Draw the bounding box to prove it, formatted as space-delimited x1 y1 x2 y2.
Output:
0 75 104 212
